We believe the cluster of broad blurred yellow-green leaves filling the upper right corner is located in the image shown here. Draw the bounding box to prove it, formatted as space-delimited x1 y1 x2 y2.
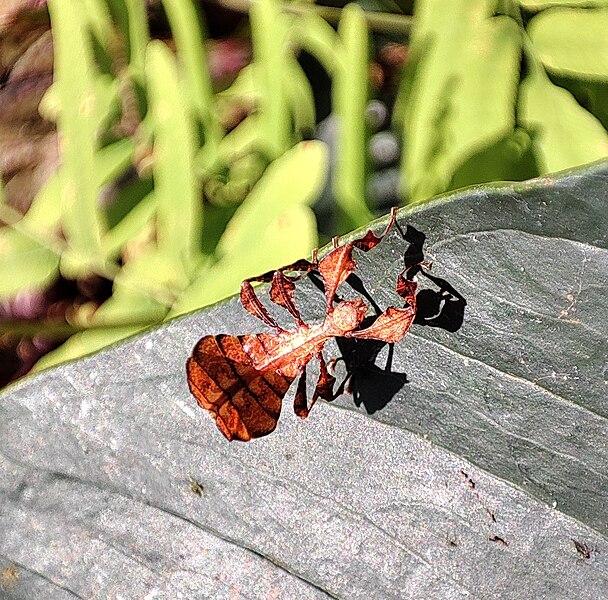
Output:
395 0 608 202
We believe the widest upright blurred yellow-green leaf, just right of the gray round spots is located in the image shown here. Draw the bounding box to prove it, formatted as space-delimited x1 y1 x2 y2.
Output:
399 0 521 201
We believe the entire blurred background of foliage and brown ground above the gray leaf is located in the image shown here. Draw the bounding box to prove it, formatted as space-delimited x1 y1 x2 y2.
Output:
0 0 608 386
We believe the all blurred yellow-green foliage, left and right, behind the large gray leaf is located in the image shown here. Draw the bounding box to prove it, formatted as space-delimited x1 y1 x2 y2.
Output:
0 0 608 366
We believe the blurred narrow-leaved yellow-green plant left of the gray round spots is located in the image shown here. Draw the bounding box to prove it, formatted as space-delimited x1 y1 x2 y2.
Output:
0 0 390 368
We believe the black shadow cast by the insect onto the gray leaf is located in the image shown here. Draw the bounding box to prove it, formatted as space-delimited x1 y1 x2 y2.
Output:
309 224 467 414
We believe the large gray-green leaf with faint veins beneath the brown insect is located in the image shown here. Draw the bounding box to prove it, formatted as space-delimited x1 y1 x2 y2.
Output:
0 163 608 599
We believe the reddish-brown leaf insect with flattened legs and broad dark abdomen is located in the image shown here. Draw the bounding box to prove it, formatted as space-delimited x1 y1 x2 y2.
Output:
186 209 424 441
